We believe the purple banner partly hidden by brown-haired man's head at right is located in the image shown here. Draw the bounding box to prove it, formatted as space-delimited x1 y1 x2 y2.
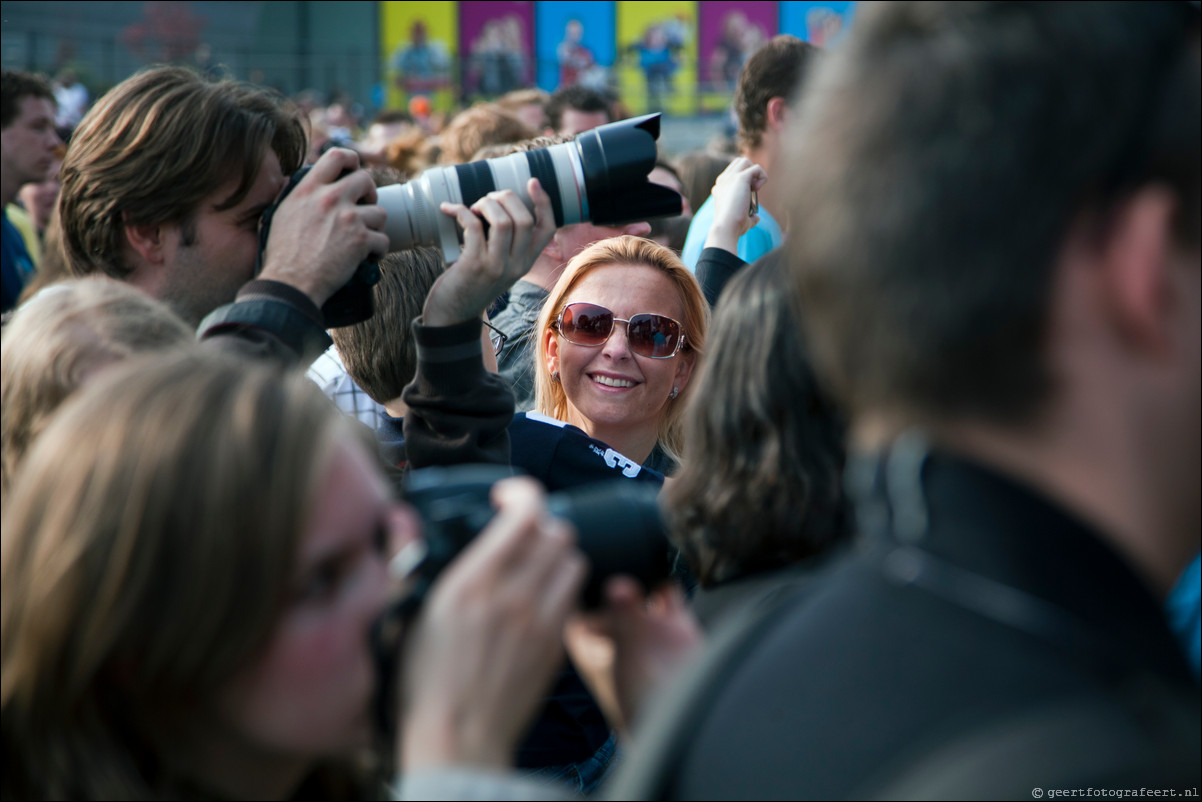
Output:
697 0 780 112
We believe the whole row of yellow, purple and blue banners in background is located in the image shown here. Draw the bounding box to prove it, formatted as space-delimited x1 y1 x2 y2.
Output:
379 0 856 115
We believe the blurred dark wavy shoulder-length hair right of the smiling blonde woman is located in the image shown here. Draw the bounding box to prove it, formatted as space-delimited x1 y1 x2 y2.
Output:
664 249 850 587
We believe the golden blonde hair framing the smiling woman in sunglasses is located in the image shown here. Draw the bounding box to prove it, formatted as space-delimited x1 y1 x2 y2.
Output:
534 234 709 462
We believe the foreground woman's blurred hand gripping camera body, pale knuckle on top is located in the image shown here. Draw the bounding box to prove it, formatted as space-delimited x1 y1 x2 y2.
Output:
398 479 587 771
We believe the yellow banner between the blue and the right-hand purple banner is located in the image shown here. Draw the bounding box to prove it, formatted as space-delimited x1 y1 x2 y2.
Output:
617 0 697 115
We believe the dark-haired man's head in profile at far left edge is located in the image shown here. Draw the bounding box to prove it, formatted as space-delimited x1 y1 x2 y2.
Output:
0 70 63 206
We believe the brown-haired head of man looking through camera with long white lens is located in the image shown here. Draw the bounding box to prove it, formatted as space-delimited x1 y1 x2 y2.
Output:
59 67 305 322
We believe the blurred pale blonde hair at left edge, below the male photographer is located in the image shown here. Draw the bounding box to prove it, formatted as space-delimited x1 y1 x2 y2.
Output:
0 277 195 498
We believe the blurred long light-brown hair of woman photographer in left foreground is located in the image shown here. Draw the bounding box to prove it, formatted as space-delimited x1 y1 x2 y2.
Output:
0 351 346 798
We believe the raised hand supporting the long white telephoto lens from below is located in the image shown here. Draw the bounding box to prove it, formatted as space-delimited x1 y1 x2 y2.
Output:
422 178 555 326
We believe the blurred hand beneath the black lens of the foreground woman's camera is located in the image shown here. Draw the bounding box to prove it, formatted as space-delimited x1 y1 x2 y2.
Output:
564 576 706 733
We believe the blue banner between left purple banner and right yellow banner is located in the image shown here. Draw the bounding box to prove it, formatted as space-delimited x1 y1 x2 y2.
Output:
535 0 617 91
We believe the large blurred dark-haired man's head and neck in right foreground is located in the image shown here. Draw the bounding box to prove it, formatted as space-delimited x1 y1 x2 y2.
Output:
786 2 1202 588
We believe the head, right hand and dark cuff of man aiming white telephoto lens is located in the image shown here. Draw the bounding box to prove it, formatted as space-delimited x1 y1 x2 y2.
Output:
59 67 388 360
